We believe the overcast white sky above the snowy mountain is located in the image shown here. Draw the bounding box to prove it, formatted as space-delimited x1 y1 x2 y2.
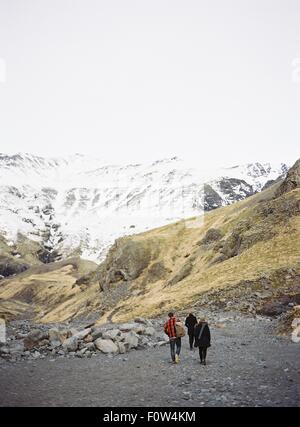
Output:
0 0 300 166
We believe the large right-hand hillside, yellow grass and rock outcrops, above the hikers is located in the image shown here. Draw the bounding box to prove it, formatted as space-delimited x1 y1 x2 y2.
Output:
93 161 300 321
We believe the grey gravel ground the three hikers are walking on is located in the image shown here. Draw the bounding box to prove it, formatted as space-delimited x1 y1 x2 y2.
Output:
0 318 300 407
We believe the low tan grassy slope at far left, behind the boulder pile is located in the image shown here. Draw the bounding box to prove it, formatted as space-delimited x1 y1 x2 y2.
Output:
0 258 100 323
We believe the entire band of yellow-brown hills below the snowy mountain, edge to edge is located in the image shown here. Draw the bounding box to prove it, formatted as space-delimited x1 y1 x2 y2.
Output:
0 161 300 323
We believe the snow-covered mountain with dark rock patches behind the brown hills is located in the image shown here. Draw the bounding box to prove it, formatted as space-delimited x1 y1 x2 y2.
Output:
0 154 288 260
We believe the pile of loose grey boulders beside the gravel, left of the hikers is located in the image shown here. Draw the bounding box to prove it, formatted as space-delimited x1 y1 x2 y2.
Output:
0 318 168 361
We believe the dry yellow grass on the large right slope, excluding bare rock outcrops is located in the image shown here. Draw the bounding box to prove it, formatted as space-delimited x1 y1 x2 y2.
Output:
96 181 300 322
